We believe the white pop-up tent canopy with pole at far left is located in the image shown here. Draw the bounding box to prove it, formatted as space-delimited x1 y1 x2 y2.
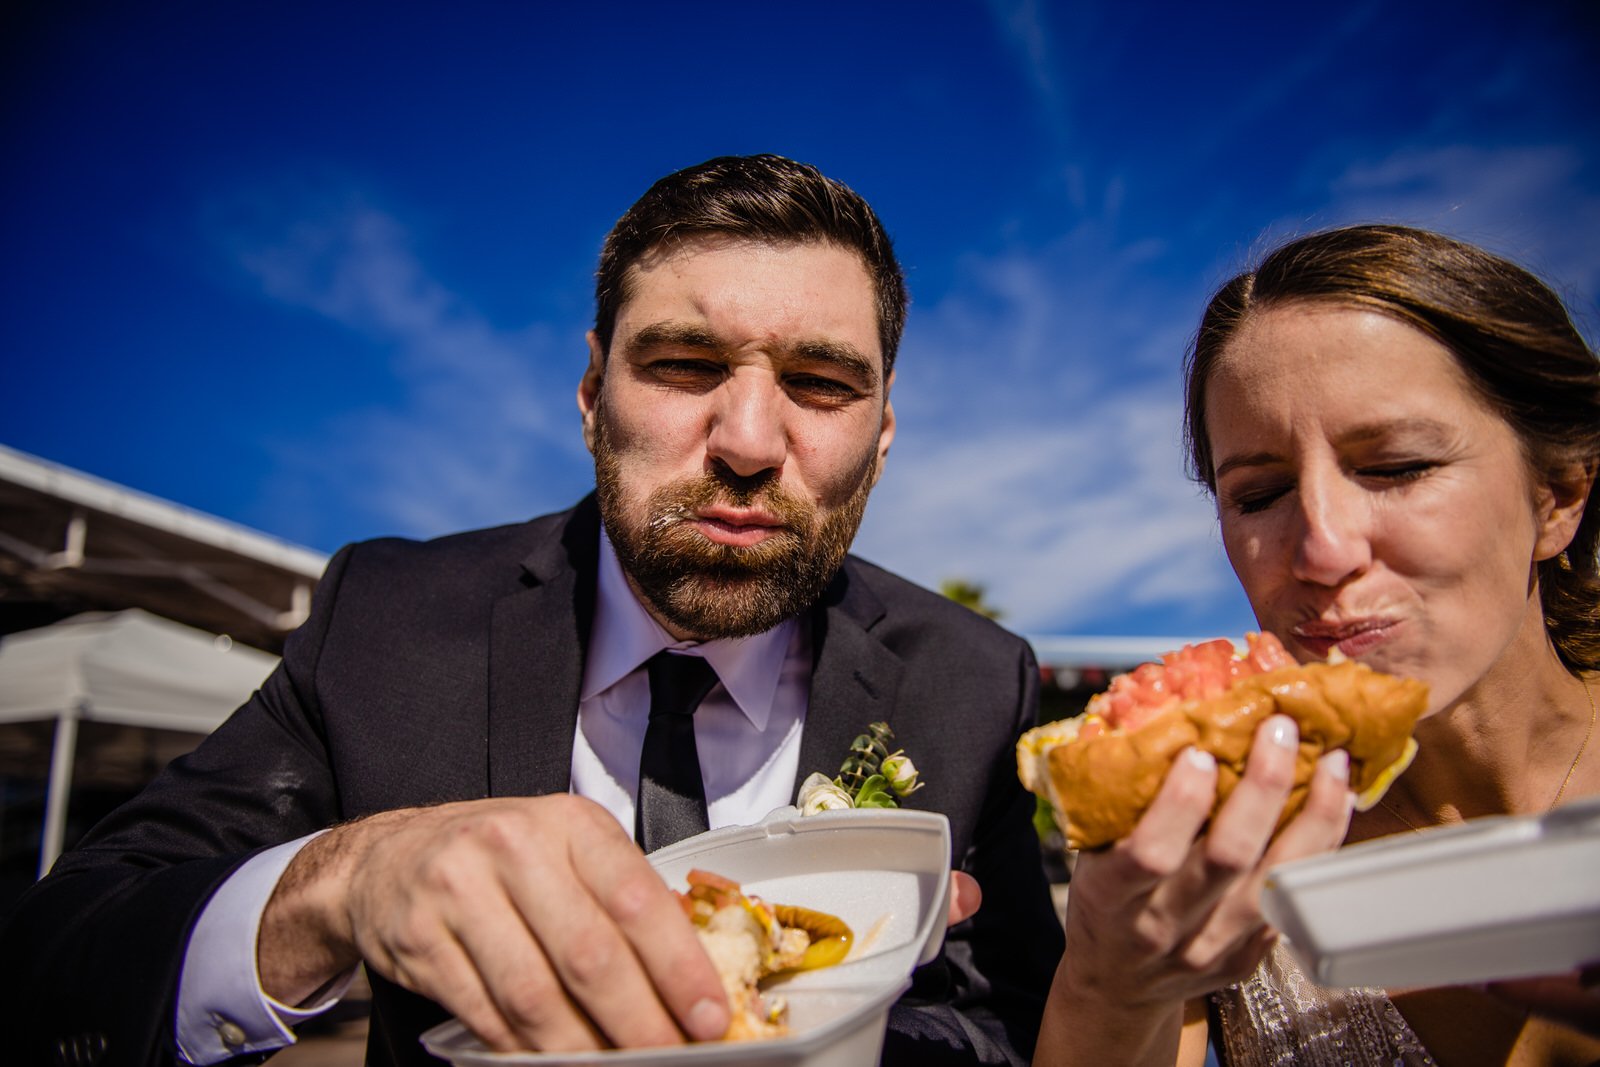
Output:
0 608 278 873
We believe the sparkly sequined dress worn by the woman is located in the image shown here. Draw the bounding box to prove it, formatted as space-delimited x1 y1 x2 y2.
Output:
1211 944 1437 1067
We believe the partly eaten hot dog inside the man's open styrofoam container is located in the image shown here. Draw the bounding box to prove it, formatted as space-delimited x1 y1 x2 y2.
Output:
678 870 851 1041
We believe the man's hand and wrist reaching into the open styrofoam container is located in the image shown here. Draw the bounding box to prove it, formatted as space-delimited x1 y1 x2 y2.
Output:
258 793 728 1051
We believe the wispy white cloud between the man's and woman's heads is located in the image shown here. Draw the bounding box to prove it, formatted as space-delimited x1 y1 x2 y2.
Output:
858 222 1248 633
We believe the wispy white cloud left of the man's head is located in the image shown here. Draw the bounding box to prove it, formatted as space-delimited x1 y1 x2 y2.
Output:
218 184 589 547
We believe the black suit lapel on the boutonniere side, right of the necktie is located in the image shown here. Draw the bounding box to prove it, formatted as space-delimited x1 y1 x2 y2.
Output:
795 560 904 792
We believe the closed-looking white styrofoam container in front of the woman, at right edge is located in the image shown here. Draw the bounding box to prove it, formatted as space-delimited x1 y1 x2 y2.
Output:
1262 797 1600 987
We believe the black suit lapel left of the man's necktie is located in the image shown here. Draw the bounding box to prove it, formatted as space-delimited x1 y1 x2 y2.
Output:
488 496 600 797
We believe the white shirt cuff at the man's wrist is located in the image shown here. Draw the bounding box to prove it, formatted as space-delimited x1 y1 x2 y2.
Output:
174 833 355 1064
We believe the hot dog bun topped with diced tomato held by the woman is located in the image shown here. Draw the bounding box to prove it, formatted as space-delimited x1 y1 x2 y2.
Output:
1016 633 1427 848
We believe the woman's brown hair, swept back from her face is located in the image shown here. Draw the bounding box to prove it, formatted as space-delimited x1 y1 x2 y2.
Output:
1184 226 1600 672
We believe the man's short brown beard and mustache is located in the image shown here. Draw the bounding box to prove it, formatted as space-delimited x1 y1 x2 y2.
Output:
594 411 874 640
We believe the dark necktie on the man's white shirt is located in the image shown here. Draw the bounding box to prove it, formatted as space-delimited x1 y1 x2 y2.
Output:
634 651 717 853
